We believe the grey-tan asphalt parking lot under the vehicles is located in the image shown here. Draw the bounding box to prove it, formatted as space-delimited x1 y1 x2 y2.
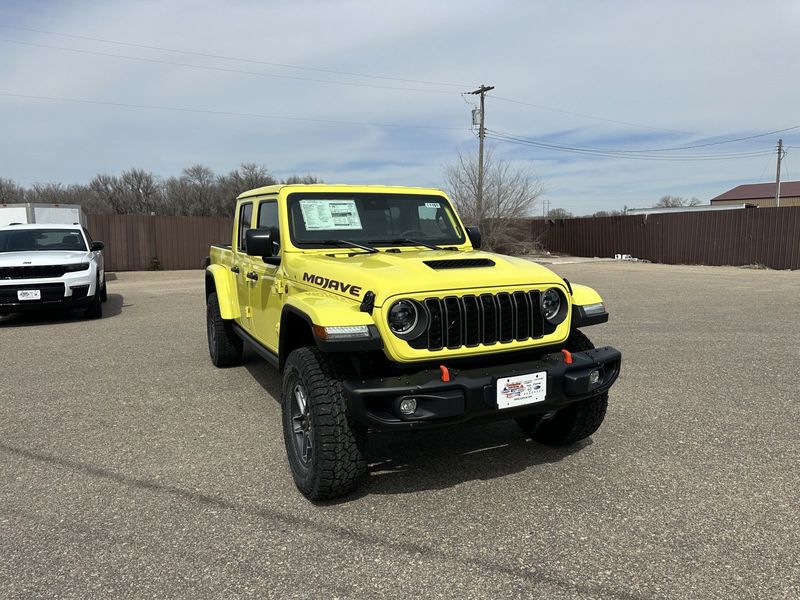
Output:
0 263 800 599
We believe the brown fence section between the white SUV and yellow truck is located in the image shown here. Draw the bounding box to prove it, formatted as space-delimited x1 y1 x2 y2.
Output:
88 215 233 271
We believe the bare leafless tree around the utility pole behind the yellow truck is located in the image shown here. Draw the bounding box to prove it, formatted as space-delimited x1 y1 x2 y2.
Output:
445 148 544 253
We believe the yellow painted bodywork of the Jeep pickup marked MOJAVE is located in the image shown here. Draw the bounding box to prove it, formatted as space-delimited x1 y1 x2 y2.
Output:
209 184 602 363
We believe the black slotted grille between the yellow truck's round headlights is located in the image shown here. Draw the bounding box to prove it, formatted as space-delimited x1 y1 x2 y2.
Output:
408 290 544 350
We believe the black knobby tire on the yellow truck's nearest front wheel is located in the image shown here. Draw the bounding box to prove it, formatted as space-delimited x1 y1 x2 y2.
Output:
281 348 367 501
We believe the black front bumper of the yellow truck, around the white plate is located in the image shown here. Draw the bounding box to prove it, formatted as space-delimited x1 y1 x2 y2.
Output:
343 346 622 430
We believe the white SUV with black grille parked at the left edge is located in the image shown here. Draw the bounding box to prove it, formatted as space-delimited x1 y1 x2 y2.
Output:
0 224 107 319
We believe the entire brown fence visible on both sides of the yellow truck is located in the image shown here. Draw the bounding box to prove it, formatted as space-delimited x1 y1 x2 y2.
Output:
88 206 800 271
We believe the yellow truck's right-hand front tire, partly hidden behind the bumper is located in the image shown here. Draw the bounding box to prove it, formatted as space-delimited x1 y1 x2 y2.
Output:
517 329 608 446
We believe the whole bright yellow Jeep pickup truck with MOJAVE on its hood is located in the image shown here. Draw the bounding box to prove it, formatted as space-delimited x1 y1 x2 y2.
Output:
206 184 621 500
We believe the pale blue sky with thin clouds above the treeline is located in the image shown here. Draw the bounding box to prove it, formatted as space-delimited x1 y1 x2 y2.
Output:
0 0 800 214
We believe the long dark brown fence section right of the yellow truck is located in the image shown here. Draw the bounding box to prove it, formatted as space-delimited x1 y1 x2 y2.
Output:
529 206 800 269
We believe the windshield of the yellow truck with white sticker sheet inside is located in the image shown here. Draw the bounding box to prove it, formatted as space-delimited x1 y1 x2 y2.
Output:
288 192 465 248
